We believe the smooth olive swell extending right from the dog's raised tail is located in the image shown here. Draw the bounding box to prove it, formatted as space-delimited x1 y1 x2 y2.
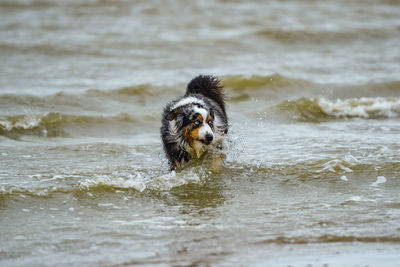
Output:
222 74 400 103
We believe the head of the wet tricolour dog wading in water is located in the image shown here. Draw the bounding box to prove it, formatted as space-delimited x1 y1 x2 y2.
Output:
166 103 214 157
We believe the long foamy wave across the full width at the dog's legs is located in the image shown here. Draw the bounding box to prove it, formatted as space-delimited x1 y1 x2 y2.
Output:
0 158 400 200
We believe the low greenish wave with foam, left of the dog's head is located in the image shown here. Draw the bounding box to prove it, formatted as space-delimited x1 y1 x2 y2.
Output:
0 113 148 137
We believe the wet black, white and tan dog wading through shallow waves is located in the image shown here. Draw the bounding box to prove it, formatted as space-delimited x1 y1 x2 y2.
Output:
160 75 228 170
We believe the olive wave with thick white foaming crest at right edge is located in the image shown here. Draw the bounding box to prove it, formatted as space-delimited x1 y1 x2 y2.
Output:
275 97 400 122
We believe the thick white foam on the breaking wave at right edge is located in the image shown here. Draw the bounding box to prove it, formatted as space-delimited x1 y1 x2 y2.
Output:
318 97 400 118
